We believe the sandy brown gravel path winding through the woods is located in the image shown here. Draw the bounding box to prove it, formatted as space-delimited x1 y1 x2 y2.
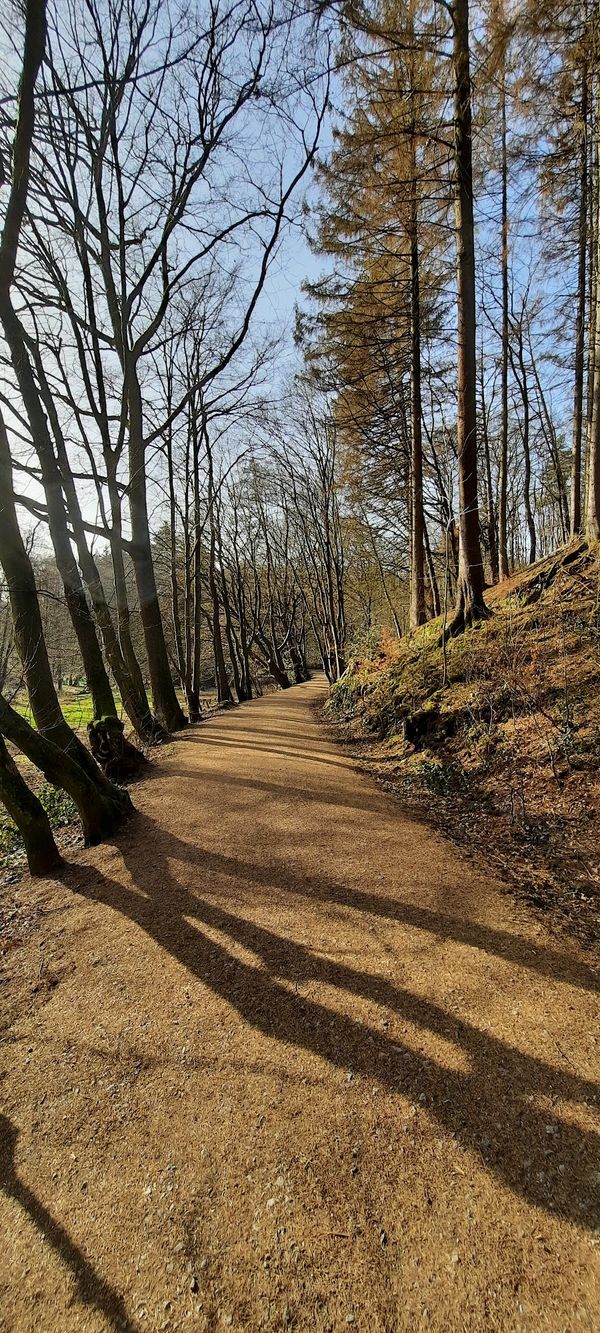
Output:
0 681 600 1333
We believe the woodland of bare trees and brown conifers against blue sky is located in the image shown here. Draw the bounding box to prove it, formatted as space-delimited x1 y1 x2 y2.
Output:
0 0 600 870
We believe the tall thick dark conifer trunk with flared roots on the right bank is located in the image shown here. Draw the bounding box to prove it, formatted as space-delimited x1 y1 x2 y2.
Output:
449 0 489 633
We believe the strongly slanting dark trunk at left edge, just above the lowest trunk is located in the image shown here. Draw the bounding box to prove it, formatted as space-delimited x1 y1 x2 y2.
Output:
0 694 133 846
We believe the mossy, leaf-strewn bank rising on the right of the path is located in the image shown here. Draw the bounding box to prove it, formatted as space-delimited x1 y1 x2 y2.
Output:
327 547 600 944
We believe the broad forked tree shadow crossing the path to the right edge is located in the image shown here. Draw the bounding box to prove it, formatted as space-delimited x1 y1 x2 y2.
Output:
65 816 600 1228
